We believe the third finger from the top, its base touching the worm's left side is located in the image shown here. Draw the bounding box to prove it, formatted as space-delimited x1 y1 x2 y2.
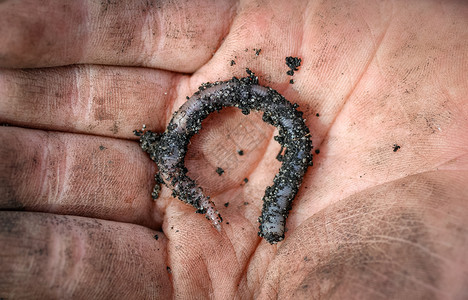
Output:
0 127 162 228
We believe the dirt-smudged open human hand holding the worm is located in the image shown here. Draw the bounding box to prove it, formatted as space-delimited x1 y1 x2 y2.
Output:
0 0 468 299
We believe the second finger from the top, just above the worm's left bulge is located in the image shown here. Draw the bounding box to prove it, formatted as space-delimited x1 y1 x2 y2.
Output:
0 66 180 138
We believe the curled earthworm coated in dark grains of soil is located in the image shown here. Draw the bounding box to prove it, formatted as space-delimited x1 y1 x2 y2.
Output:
136 72 312 244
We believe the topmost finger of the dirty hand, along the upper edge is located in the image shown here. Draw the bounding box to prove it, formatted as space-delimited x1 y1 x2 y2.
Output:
0 0 235 72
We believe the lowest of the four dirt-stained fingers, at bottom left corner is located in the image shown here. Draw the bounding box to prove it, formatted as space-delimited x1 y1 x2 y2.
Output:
0 212 171 299
